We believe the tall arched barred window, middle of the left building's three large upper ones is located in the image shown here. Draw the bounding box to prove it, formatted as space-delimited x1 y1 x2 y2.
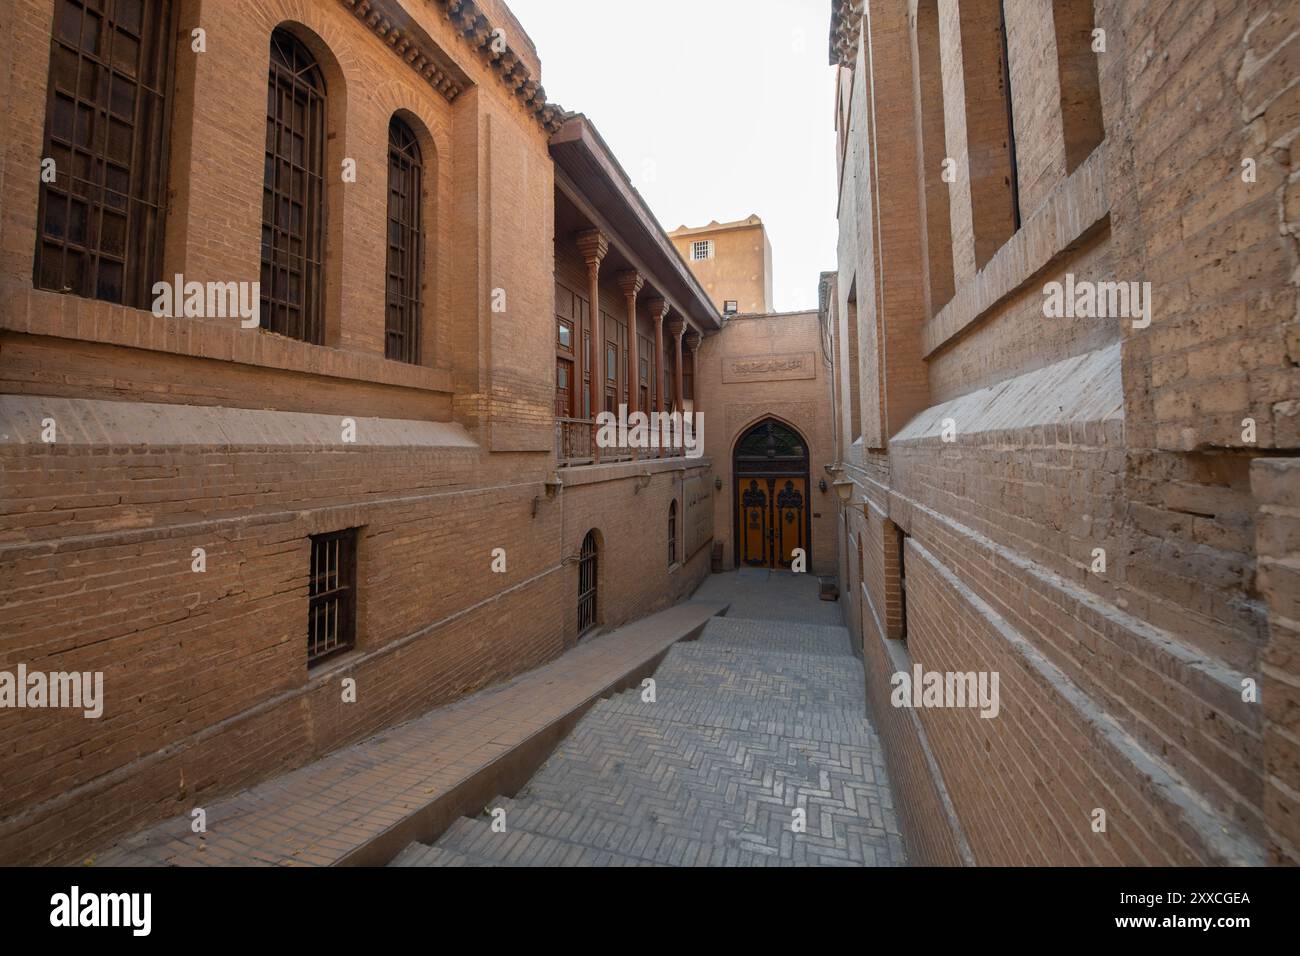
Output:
261 29 325 345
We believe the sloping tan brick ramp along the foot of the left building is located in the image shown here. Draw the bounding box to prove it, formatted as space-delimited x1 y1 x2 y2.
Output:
94 598 725 866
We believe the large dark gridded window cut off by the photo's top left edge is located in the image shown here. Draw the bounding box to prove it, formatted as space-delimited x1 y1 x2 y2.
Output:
33 0 176 308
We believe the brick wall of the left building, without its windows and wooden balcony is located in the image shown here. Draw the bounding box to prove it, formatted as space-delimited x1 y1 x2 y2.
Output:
0 0 709 862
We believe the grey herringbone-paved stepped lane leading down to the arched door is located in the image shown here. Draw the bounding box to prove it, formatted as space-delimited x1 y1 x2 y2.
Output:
393 570 905 866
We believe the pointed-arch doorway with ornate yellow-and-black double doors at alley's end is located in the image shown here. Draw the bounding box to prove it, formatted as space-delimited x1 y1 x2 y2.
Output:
732 419 813 570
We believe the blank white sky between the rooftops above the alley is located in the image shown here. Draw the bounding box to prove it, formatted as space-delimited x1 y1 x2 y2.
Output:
507 0 836 312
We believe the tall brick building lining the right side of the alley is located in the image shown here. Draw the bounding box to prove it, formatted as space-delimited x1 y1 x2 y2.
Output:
826 0 1300 864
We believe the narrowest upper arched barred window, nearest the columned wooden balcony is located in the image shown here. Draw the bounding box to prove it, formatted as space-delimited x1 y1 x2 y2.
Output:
384 116 424 364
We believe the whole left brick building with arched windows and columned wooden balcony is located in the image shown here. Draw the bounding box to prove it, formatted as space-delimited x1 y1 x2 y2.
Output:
0 0 722 862
